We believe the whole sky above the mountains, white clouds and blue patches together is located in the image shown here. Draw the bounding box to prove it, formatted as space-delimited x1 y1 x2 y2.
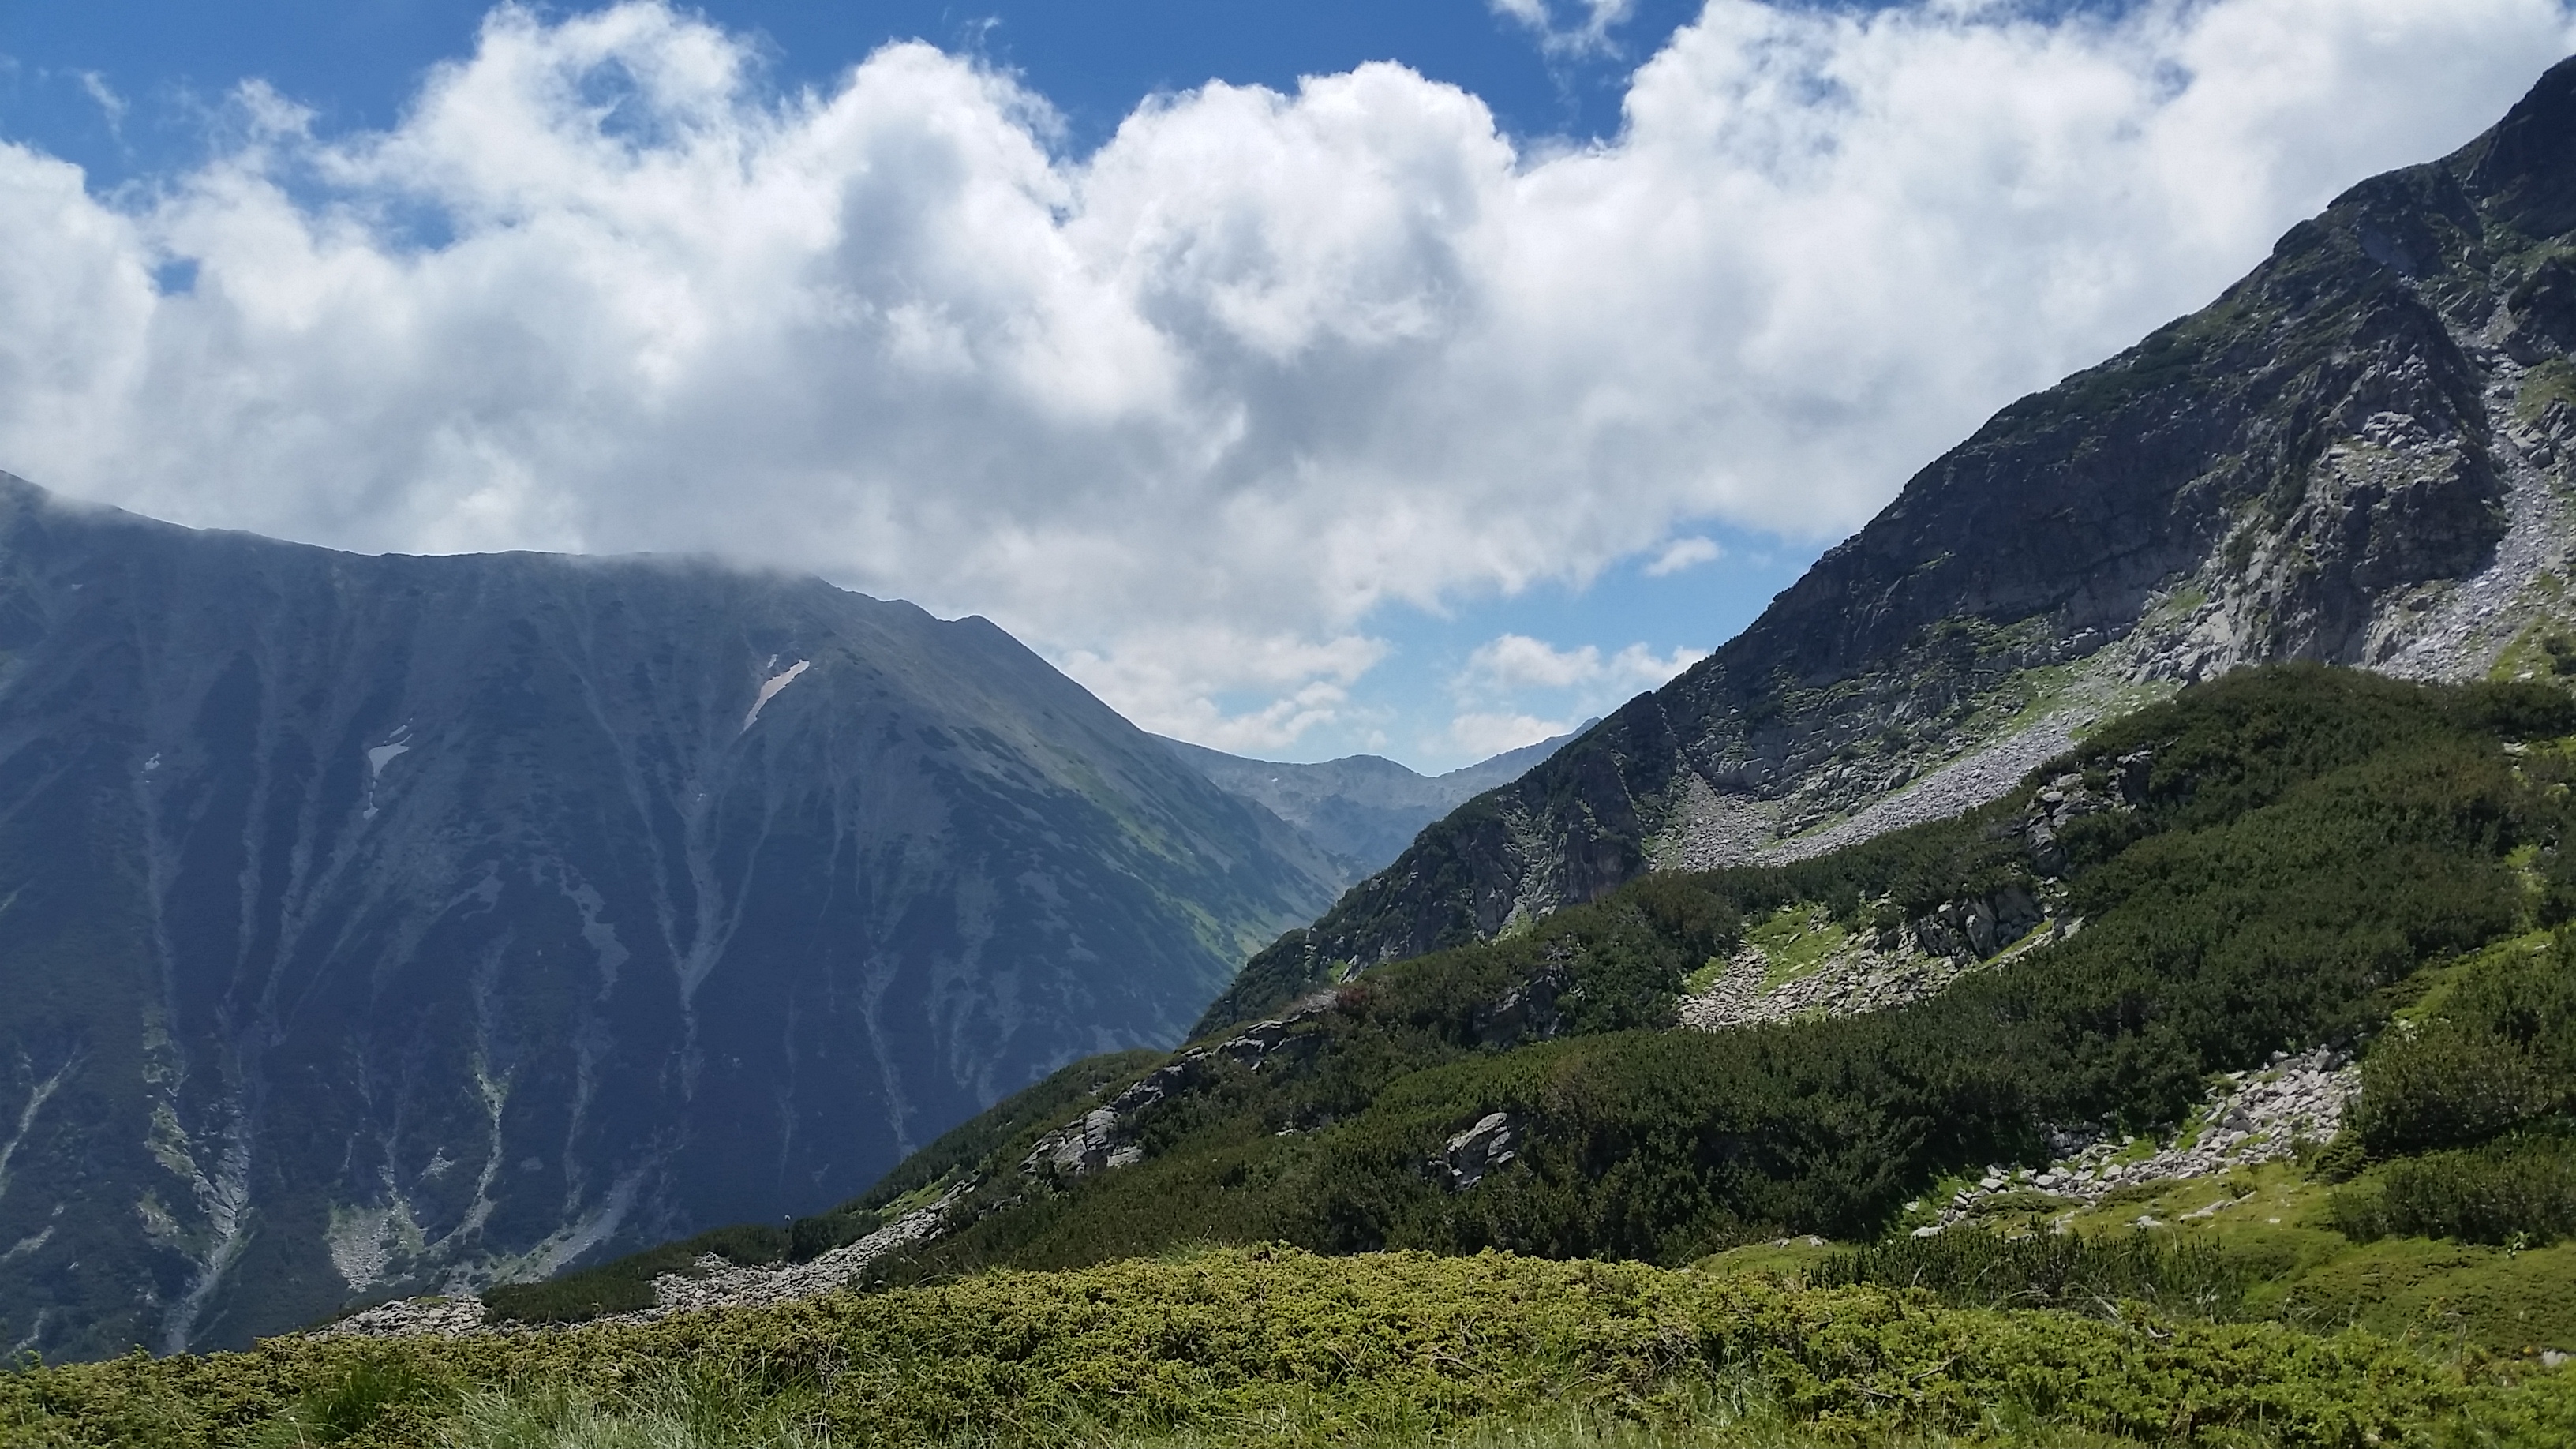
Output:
0 0 2576 769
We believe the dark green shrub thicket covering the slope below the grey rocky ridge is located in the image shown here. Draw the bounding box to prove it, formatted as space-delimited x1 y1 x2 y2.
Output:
808 665 2576 1282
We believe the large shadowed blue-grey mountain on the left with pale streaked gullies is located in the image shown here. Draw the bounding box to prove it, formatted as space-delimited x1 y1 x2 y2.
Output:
0 474 1335 1356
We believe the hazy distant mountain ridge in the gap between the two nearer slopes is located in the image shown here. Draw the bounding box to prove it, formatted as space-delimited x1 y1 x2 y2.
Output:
1164 722 1594 885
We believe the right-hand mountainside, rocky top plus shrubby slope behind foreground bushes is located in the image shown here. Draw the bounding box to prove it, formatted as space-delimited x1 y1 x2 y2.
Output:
286 47 2576 1351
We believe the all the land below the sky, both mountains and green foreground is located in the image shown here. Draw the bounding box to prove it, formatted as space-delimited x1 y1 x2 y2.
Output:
0 39 2576 1447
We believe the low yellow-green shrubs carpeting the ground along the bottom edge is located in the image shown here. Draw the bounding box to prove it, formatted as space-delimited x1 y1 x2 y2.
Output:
0 1248 2576 1449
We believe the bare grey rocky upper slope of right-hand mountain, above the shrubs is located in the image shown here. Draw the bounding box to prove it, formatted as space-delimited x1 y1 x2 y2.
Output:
1200 62 2576 1028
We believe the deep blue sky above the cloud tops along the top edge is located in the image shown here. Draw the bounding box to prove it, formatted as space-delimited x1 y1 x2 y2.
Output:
0 0 1698 181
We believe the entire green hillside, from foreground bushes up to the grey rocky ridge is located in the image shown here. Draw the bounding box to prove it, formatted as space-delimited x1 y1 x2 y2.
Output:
15 665 2576 1447
